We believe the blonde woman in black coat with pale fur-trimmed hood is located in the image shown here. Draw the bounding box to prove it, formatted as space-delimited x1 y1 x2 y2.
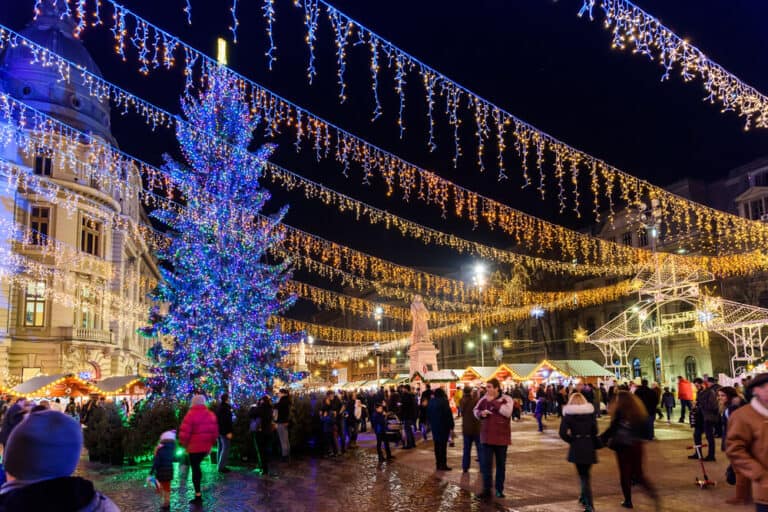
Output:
560 392 600 512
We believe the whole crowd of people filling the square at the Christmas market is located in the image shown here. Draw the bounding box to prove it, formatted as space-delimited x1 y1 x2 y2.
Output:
0 373 768 512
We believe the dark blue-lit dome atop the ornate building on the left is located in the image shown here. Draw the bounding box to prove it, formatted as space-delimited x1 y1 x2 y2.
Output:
0 0 114 143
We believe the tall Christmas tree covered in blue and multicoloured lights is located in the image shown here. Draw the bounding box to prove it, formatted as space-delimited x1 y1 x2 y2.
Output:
145 70 299 400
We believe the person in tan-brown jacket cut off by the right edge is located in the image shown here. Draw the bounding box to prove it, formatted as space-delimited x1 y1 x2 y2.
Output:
725 373 768 512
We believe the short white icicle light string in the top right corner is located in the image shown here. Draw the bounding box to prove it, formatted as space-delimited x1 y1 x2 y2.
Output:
579 0 768 130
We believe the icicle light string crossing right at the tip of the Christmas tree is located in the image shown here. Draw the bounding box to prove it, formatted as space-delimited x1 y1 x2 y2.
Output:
27 11 664 264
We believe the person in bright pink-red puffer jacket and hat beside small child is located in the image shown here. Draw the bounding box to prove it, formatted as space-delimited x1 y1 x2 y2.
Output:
179 395 219 504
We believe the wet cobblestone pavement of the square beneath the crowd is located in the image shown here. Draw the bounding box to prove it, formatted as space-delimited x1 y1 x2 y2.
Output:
79 418 754 512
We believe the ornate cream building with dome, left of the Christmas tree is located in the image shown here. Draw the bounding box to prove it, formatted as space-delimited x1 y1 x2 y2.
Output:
0 5 159 385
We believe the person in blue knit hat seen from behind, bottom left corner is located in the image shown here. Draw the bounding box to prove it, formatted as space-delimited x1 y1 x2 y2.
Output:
0 409 120 512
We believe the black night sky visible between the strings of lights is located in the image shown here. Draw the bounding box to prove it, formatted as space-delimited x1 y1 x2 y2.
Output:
0 0 768 284
